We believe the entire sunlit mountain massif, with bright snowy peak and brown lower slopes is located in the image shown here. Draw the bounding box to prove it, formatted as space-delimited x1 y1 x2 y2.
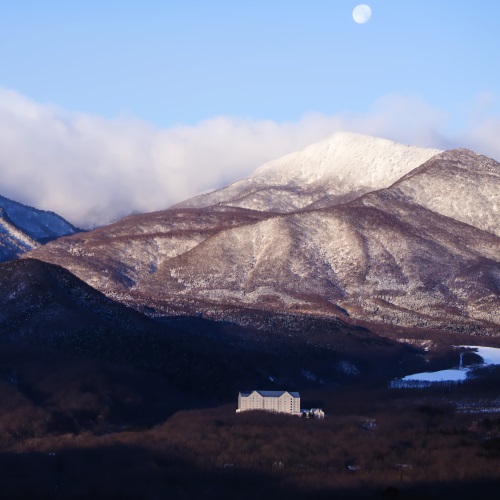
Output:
26 134 500 334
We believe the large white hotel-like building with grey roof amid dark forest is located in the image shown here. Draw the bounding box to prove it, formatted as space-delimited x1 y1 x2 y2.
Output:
236 391 300 415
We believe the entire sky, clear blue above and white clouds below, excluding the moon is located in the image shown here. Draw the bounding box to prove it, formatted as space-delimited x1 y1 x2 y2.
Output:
0 0 500 224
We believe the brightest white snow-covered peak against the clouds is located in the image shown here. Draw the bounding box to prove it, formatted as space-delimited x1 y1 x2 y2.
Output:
176 132 440 212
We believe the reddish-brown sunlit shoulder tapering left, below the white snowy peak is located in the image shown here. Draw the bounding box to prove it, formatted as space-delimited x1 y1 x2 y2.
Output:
23 207 270 293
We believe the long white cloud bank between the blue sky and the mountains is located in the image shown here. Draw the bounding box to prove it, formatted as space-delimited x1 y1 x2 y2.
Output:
0 89 500 227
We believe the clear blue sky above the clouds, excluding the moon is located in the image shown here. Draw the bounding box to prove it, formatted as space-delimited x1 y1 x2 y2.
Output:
0 0 500 127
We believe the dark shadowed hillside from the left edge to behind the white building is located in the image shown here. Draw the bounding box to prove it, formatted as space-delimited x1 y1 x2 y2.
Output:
0 259 434 458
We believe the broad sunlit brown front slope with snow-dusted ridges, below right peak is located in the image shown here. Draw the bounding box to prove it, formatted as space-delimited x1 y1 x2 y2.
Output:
134 188 500 331
